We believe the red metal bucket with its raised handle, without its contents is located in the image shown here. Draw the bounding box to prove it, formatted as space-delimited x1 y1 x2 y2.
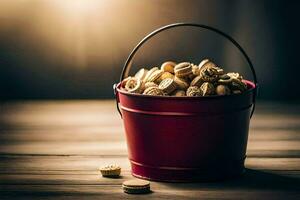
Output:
114 23 257 182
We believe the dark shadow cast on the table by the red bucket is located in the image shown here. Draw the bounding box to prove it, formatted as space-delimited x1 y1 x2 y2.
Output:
159 169 300 191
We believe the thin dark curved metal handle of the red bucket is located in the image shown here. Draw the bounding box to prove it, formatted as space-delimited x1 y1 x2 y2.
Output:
114 23 258 118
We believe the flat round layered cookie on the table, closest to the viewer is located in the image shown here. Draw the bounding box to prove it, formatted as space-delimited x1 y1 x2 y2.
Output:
122 179 151 194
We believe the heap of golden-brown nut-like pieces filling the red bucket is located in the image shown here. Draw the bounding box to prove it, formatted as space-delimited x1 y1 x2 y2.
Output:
121 59 247 97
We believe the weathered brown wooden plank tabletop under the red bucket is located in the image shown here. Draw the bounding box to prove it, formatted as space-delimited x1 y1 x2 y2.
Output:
0 101 300 199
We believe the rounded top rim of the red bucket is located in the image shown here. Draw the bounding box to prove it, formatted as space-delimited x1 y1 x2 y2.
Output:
116 79 257 100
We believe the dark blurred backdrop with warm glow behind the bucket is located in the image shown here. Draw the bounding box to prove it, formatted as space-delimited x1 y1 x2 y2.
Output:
0 0 300 102
